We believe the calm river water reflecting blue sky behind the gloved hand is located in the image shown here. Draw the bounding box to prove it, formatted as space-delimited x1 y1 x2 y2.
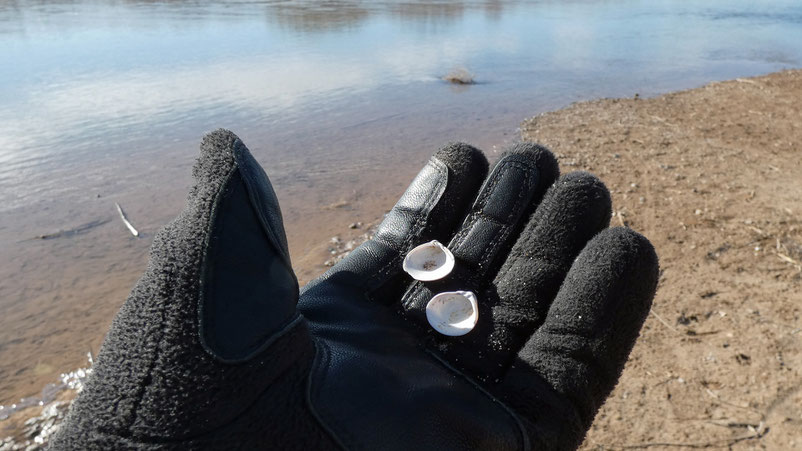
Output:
0 0 802 403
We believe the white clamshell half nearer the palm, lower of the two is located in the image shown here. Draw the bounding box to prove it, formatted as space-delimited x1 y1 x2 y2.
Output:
426 291 479 337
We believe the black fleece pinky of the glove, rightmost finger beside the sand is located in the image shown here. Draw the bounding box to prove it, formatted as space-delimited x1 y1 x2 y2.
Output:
499 227 659 449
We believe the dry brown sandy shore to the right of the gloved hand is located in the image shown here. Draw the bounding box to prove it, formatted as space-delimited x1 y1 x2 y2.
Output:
0 71 802 449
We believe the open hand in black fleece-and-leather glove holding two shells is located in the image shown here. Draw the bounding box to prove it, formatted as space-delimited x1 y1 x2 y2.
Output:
51 130 658 450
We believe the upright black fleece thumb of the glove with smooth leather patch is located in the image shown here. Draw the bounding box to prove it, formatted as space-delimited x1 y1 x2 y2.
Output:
53 130 314 449
